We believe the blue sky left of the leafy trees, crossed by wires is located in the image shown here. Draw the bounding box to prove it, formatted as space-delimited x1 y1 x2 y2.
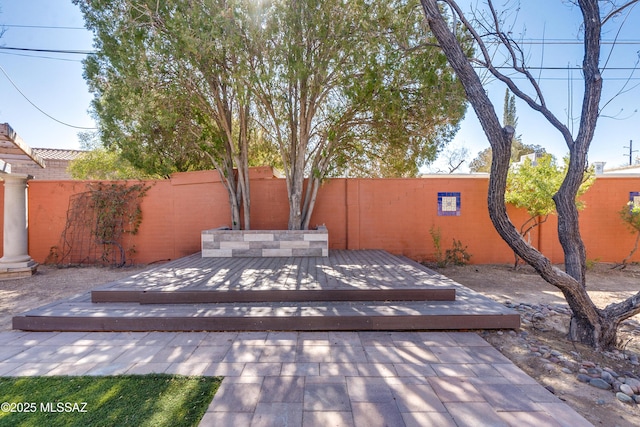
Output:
0 0 95 149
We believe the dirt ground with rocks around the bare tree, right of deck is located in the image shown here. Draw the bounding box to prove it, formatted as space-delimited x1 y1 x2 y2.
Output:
437 264 640 427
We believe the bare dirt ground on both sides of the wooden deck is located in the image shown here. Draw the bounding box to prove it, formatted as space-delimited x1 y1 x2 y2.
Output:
0 264 640 427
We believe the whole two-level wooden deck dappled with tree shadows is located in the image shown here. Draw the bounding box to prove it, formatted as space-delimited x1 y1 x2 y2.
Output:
13 251 520 331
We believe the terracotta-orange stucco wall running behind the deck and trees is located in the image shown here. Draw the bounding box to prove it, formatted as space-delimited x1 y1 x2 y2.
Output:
13 171 640 263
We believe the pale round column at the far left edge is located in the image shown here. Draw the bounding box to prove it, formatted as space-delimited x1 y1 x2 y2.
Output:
0 174 37 272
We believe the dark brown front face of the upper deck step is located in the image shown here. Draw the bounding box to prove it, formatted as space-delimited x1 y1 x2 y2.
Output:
91 288 456 304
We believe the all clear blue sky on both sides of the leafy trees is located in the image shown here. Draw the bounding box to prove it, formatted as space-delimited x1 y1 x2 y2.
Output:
0 0 640 172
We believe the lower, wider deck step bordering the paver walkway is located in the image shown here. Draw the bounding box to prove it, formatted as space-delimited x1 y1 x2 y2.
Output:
13 302 520 331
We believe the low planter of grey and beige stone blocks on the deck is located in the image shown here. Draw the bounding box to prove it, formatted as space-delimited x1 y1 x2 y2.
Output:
202 226 329 258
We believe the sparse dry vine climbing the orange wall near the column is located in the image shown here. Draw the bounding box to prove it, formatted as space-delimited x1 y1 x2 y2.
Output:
47 183 150 267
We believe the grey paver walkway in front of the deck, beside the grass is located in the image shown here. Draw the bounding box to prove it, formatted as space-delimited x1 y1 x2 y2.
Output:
0 331 591 427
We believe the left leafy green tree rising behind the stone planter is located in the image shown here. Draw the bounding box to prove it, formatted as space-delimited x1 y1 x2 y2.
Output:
75 0 270 229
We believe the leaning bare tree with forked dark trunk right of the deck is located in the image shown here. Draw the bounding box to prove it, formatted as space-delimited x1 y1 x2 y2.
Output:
421 0 640 348
